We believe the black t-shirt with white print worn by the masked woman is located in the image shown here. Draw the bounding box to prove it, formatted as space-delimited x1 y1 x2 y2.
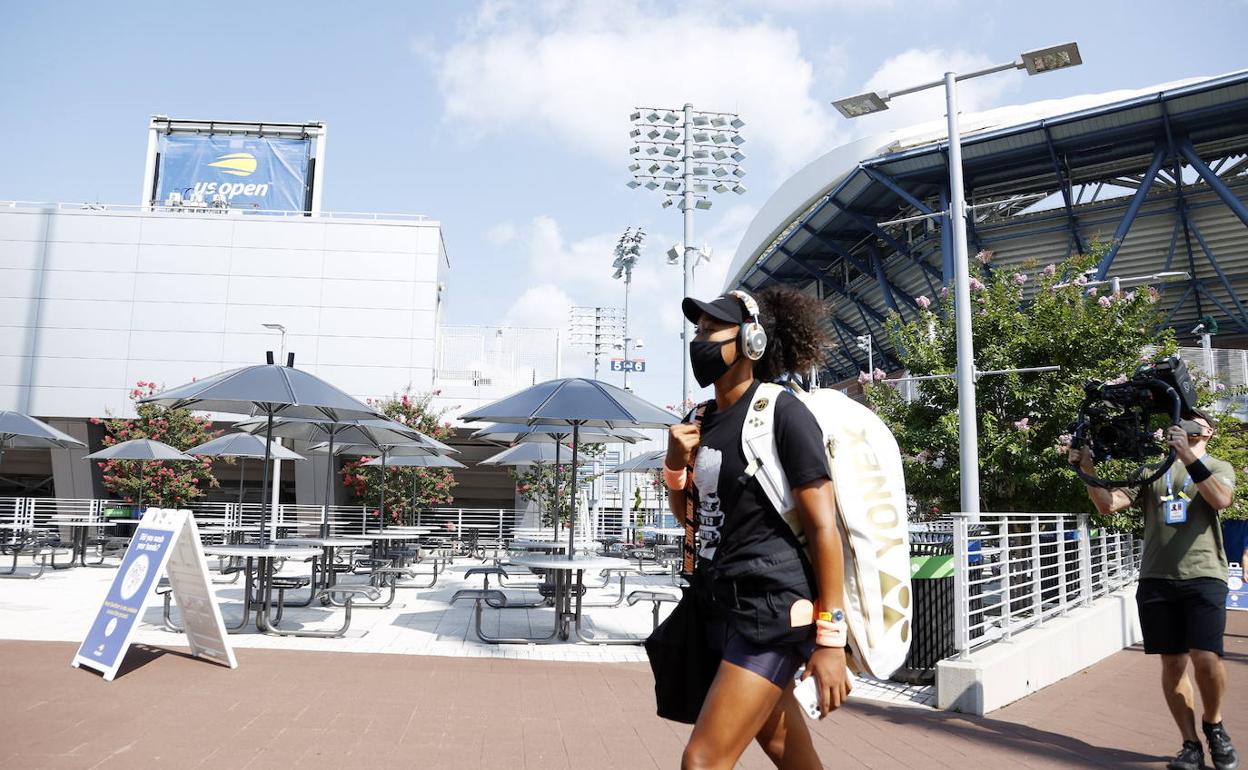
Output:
694 382 830 565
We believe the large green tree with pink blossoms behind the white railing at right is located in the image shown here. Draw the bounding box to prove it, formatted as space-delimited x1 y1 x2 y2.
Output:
859 246 1177 517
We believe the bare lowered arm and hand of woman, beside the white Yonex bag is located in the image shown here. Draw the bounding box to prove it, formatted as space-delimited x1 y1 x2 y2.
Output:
792 478 852 719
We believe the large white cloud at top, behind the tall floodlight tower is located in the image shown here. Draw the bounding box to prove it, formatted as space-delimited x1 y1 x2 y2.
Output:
437 2 839 172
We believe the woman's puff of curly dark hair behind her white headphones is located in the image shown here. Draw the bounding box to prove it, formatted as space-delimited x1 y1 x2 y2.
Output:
754 286 831 382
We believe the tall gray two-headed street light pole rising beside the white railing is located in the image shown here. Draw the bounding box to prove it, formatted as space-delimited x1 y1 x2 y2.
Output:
832 42 1083 514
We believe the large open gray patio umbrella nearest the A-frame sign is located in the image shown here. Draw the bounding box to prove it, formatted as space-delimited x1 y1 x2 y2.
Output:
139 352 381 544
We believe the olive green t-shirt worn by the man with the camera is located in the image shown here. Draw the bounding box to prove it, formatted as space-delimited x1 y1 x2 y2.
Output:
1123 454 1236 582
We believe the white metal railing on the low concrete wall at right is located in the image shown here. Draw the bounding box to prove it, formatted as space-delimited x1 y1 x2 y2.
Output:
931 513 1142 654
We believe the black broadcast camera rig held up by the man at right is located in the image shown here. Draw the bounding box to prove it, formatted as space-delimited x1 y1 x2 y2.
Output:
1071 356 1198 488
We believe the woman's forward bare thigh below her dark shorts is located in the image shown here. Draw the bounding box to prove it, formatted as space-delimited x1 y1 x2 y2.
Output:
680 660 783 770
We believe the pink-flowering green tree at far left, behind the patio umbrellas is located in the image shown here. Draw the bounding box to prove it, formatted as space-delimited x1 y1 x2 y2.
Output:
91 381 223 507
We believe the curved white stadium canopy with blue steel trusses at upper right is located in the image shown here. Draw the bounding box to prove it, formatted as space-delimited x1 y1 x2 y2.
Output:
725 70 1248 379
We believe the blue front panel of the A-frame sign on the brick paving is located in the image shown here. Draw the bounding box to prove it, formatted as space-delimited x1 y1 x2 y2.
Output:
77 527 176 669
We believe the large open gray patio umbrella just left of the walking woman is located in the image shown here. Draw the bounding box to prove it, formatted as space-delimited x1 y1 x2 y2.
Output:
461 377 680 559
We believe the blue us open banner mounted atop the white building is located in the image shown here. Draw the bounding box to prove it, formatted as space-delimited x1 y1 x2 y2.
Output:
154 134 312 211
